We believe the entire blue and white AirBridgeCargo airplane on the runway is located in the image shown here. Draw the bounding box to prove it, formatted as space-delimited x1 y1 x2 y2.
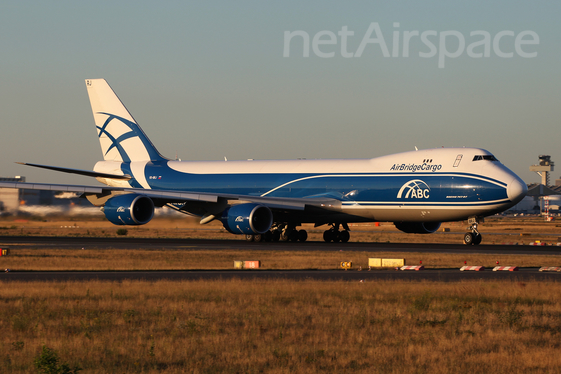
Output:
0 79 527 244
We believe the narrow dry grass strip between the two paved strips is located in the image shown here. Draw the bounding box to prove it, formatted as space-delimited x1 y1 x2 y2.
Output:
0 247 561 271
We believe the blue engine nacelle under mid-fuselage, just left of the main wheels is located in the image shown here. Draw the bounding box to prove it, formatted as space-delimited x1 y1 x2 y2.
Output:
220 203 273 235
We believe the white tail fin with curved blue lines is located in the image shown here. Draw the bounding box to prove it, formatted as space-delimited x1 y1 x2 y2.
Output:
86 79 166 162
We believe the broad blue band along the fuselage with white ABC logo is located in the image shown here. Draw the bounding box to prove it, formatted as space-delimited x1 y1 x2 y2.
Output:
130 162 509 207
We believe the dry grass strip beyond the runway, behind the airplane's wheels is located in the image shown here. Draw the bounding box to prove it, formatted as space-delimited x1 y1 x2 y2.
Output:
0 213 561 244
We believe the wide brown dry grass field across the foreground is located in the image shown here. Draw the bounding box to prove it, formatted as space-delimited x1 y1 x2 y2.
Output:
0 280 561 373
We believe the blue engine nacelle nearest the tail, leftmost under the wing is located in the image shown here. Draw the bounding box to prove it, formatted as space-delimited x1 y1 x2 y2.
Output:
103 194 154 225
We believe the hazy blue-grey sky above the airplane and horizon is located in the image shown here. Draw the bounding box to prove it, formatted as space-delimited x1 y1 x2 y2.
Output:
0 0 561 185
